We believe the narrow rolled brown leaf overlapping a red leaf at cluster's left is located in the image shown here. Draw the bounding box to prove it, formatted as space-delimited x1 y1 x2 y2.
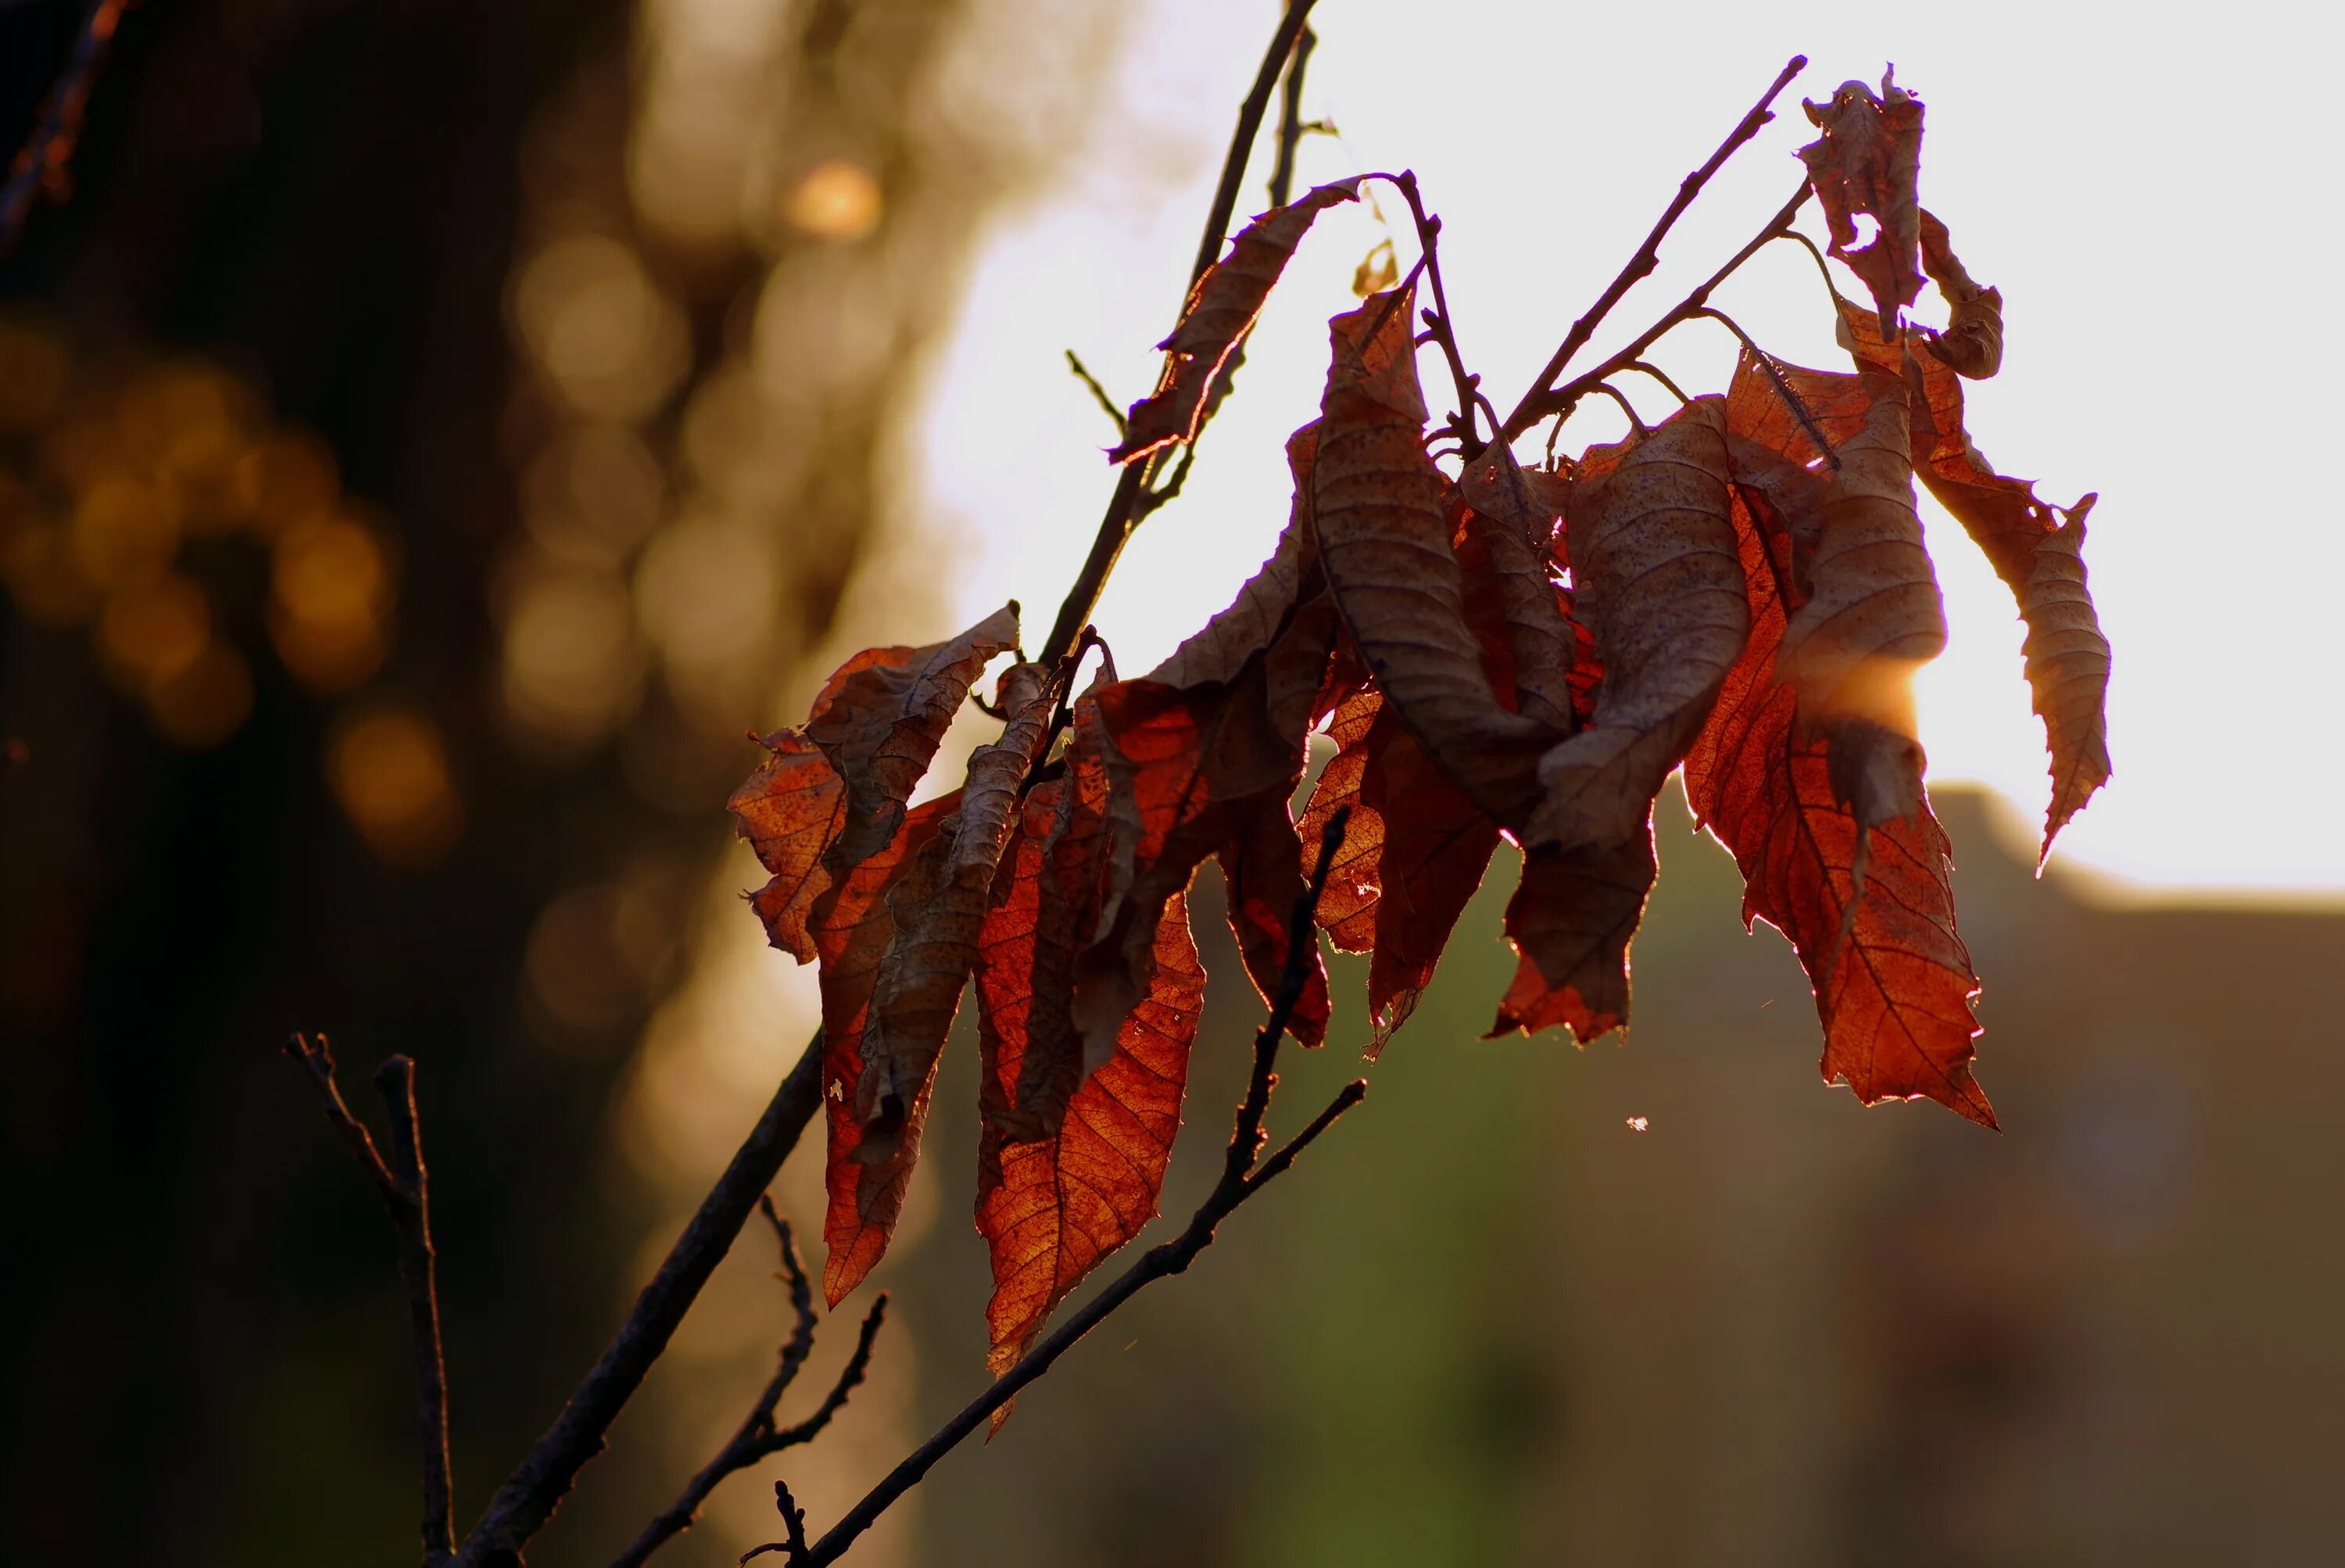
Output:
856 664 1058 1144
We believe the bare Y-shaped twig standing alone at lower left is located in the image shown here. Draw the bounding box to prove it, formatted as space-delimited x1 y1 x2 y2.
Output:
284 1033 455 1566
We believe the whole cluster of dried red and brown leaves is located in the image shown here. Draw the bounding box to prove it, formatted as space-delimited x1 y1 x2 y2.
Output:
732 80 2108 1369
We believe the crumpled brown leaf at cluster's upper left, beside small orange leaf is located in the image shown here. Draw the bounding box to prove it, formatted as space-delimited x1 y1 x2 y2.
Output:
802 603 1018 881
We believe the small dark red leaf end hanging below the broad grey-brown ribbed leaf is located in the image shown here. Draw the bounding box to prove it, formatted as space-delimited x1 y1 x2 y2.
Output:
1484 815 1656 1045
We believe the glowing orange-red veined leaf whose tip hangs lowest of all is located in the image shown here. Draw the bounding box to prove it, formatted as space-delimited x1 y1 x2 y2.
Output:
978 886 1205 1378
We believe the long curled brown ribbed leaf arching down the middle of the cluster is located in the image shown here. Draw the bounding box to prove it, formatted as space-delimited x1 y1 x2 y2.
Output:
1311 291 1557 825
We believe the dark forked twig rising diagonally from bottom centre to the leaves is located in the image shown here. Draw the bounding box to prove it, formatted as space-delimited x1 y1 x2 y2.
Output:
783 811 1367 1568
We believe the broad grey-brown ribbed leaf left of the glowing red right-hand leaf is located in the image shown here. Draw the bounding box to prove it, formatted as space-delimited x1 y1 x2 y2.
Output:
1527 396 1749 848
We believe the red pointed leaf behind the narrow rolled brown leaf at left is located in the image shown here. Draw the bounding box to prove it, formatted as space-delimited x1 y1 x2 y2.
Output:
811 789 961 1305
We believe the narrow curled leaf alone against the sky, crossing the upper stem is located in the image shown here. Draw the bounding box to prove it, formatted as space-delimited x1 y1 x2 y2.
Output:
1107 176 1360 462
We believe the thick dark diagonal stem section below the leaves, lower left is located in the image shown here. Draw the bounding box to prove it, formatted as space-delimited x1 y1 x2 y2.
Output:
457 1031 823 1568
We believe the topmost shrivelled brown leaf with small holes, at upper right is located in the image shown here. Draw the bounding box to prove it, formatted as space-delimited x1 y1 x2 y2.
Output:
1799 68 1921 338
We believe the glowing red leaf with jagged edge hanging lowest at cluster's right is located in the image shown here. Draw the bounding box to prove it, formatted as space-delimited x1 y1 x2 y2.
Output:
1686 391 1996 1127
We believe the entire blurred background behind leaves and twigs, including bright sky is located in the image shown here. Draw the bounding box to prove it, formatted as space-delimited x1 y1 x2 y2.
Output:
0 0 2345 1568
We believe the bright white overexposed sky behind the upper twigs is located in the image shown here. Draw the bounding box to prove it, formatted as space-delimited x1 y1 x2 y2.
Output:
919 0 2345 893
